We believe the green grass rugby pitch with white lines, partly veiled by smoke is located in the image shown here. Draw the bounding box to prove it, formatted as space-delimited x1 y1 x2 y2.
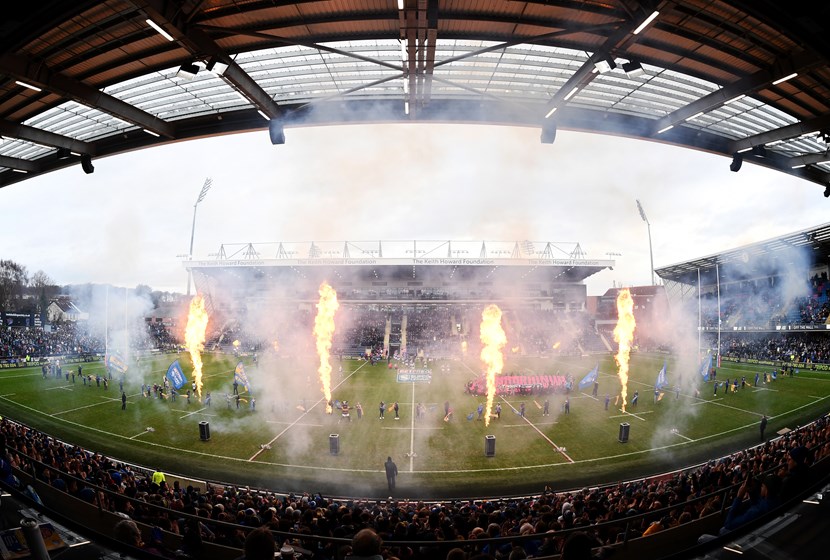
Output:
0 354 830 498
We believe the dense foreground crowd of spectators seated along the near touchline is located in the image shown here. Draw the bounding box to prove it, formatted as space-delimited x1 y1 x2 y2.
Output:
0 400 830 560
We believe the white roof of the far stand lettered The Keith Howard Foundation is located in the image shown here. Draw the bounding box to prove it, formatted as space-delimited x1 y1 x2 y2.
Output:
192 240 615 286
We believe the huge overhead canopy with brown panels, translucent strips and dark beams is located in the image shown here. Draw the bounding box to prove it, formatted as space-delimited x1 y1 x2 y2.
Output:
0 0 830 187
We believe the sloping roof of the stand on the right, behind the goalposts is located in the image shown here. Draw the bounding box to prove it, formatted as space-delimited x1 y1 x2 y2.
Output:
654 223 830 285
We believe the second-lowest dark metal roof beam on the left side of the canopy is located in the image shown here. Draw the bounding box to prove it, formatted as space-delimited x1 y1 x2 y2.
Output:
0 53 176 139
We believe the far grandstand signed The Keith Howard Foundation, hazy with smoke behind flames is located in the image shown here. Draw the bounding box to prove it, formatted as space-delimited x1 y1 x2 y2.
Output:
190 240 614 356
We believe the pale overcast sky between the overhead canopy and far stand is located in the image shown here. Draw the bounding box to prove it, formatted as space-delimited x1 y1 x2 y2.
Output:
0 124 830 295
